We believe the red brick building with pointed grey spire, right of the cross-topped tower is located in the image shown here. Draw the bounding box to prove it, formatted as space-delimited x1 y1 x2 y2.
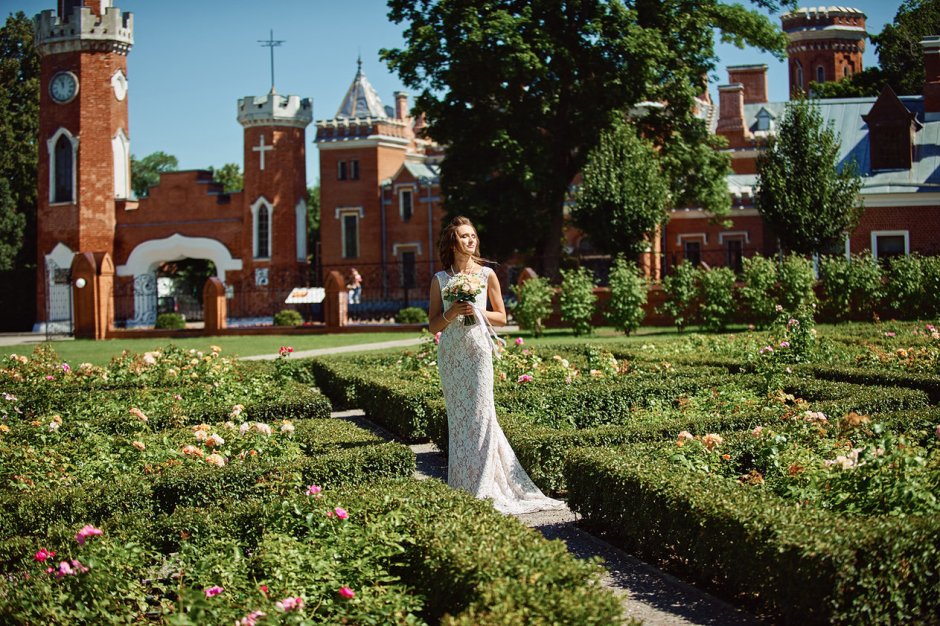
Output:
316 62 443 312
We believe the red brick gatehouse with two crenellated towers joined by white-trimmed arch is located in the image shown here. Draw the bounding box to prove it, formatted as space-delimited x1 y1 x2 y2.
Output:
35 0 313 328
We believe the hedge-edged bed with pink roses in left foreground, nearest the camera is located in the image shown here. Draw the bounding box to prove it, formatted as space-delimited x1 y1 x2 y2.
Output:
0 480 620 624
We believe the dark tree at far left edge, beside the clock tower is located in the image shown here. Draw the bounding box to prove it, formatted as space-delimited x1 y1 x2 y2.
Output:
0 11 39 269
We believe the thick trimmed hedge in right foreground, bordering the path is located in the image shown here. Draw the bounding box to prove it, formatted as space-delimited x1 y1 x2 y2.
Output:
565 444 940 624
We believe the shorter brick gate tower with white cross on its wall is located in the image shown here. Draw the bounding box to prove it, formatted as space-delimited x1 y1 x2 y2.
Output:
238 89 313 291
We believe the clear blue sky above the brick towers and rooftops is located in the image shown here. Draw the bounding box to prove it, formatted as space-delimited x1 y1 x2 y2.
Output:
9 0 900 183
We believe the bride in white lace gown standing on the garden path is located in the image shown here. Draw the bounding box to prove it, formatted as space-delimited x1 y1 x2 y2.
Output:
428 217 565 515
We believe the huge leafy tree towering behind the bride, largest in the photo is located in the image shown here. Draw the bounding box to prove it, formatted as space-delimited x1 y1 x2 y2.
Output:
382 0 791 273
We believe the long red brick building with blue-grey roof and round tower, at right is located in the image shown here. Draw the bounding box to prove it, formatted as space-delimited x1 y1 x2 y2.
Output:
664 7 940 266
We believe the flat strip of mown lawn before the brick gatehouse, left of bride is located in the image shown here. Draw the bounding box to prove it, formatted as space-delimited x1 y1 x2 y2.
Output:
0 332 418 365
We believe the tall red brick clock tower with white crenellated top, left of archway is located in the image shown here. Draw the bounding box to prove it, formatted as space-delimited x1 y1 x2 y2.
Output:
35 0 134 321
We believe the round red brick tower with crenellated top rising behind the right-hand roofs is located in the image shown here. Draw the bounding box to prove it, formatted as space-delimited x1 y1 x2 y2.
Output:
780 7 865 94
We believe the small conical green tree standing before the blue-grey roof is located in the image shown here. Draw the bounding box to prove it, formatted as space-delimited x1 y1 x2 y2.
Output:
754 98 862 254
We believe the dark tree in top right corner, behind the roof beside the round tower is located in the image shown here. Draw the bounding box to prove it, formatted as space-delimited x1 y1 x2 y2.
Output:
813 0 940 98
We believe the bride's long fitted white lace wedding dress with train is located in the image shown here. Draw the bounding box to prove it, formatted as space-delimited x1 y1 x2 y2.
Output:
436 267 565 515
